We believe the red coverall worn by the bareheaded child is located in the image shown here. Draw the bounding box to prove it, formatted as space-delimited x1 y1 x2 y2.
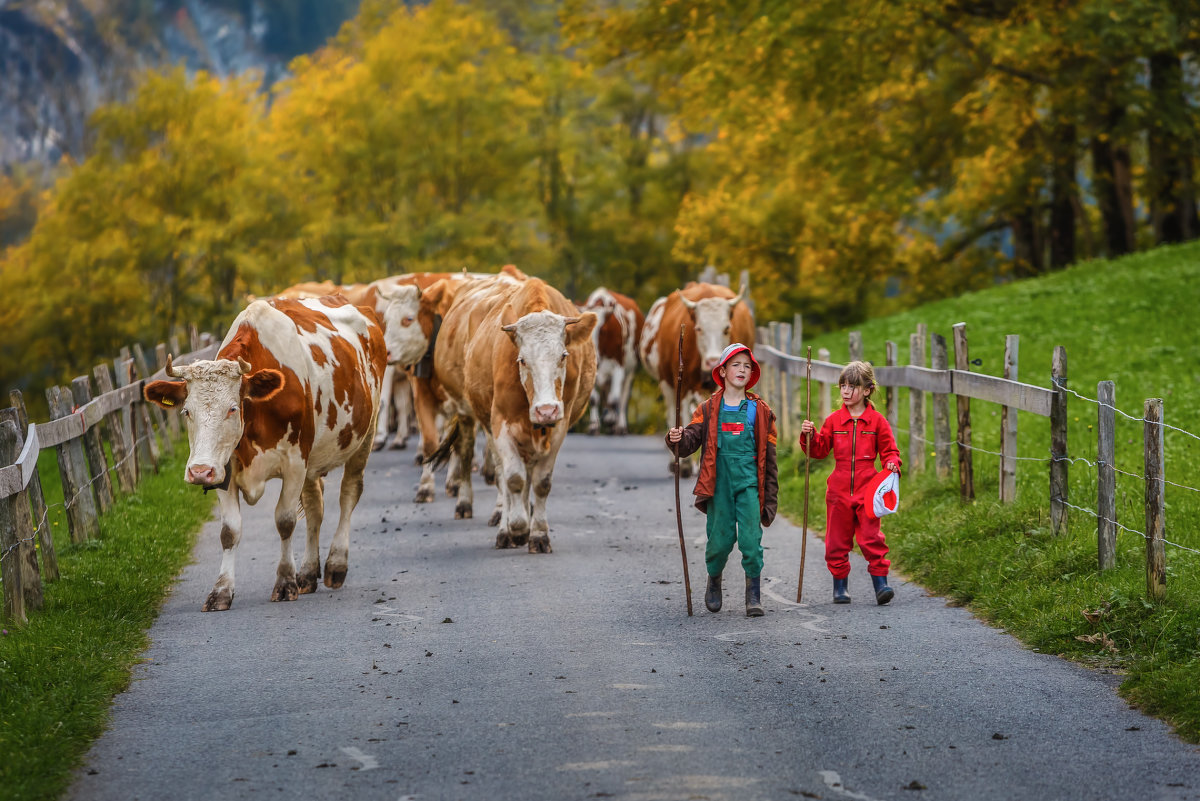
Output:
800 402 900 578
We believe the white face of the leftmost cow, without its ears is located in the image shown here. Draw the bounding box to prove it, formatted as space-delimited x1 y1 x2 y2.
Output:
176 359 246 484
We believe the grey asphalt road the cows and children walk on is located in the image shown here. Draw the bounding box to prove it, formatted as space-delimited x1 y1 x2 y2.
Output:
67 435 1200 801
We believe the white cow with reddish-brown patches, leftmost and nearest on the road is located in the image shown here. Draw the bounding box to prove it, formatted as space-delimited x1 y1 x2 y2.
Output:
144 295 386 612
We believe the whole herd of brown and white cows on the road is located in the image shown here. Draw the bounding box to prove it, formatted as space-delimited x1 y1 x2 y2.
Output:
144 265 755 612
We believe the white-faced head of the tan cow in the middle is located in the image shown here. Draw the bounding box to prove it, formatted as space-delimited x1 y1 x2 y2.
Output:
503 306 596 427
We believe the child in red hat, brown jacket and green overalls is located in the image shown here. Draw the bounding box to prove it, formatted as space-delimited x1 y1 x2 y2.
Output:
666 342 779 618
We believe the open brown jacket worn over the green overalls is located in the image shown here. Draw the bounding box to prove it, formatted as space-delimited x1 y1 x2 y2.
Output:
667 391 779 526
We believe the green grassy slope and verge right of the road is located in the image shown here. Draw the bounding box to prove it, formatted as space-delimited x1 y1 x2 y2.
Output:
780 243 1200 742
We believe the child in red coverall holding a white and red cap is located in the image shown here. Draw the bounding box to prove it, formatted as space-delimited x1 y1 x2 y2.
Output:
800 362 901 606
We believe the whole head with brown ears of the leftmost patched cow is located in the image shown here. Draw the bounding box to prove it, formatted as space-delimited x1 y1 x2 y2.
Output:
143 356 283 487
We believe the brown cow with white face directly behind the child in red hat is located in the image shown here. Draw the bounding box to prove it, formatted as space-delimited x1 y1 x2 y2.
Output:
638 282 755 476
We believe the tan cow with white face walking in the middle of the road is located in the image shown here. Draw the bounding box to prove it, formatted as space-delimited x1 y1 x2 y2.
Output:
432 275 596 553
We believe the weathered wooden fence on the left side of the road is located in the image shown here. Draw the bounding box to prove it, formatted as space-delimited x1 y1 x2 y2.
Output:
0 333 220 622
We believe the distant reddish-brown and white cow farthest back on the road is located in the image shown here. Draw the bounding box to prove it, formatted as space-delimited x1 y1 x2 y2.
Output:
583 287 646 434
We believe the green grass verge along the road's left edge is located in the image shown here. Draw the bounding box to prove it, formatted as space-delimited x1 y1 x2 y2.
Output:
0 442 212 801
